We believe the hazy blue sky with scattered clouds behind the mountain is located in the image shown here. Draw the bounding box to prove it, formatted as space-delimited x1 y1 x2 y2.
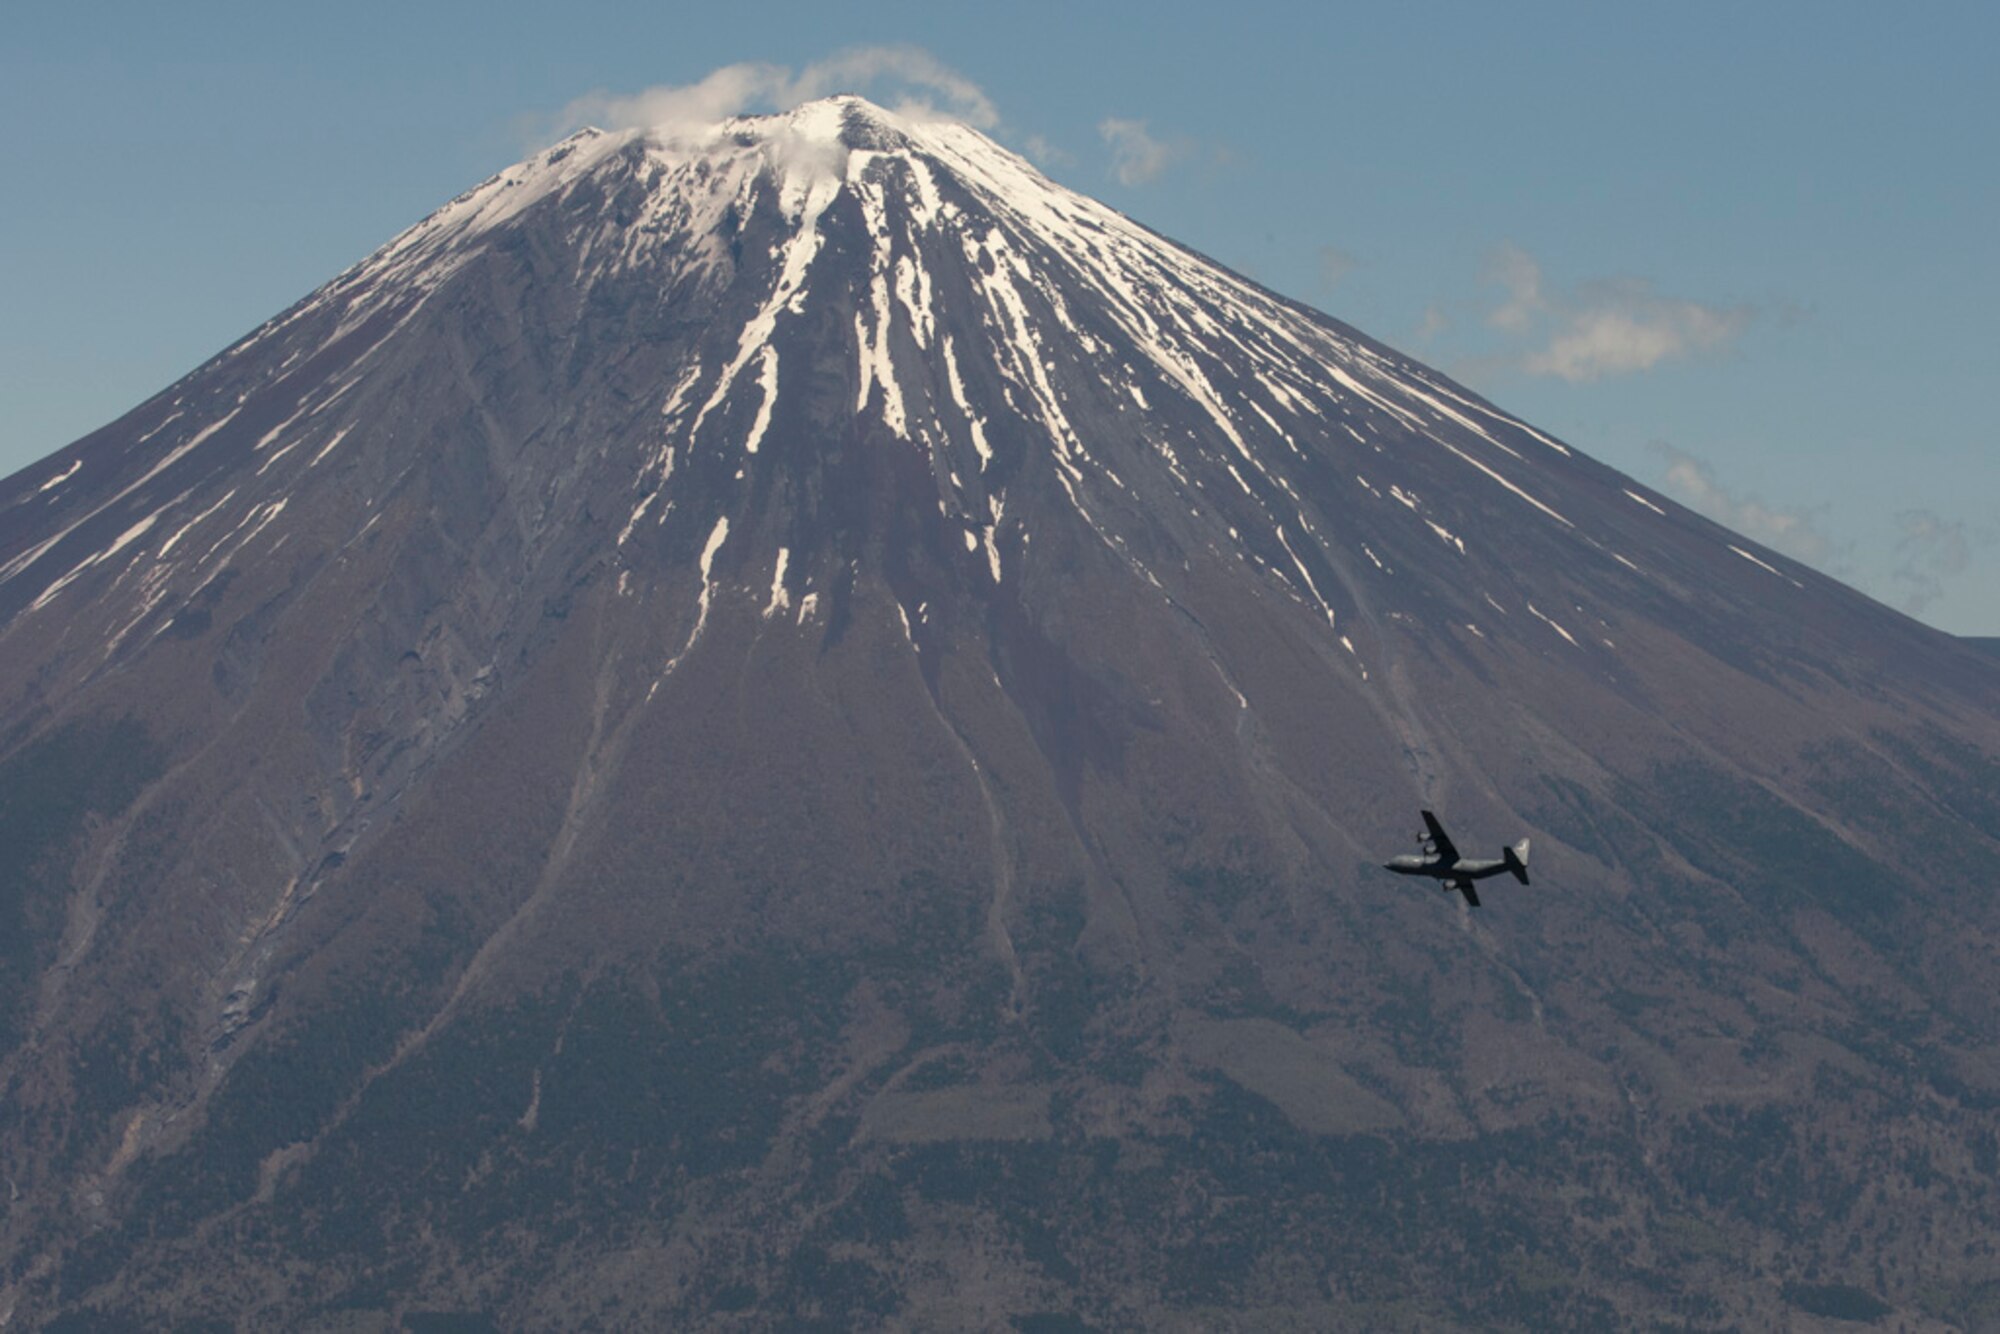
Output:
0 0 2000 634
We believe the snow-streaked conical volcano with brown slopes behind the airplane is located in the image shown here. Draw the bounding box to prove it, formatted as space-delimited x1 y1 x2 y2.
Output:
0 98 2000 1330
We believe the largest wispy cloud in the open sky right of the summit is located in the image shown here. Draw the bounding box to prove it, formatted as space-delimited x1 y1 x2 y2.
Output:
1486 244 1756 384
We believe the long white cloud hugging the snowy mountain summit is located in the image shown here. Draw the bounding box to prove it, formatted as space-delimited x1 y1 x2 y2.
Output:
562 46 1000 130
